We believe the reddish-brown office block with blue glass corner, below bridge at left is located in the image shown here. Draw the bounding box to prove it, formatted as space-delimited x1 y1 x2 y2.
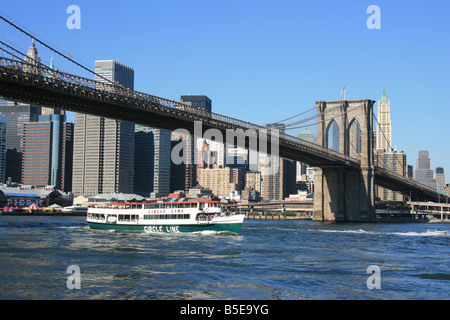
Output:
22 115 73 192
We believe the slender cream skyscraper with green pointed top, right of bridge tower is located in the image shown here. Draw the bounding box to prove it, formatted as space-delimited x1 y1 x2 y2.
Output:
376 89 392 152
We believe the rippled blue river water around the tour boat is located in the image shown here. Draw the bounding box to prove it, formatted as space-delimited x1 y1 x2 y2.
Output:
0 217 450 300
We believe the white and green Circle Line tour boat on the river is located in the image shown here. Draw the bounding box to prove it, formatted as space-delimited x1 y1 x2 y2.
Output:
87 199 244 234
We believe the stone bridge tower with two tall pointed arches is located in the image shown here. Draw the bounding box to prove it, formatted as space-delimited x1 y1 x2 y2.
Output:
313 99 375 222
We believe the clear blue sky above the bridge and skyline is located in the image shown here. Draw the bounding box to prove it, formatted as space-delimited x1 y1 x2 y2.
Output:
0 0 450 183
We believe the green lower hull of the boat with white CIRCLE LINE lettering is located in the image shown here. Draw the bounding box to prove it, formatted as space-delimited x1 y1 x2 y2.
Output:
88 222 242 234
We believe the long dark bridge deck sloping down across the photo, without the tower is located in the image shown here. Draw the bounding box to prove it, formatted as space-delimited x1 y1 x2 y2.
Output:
0 57 438 200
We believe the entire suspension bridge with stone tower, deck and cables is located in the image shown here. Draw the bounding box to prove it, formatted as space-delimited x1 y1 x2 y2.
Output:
0 16 442 221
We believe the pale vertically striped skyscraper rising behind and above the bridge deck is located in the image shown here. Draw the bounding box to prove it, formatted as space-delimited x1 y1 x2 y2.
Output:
72 60 134 196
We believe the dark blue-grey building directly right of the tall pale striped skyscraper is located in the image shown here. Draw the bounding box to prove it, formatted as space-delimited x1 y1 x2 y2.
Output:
134 125 171 198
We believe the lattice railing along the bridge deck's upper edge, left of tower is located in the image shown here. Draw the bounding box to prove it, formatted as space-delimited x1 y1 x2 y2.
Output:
0 57 359 165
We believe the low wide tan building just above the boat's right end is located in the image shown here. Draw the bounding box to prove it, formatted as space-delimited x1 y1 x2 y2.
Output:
198 165 242 196
